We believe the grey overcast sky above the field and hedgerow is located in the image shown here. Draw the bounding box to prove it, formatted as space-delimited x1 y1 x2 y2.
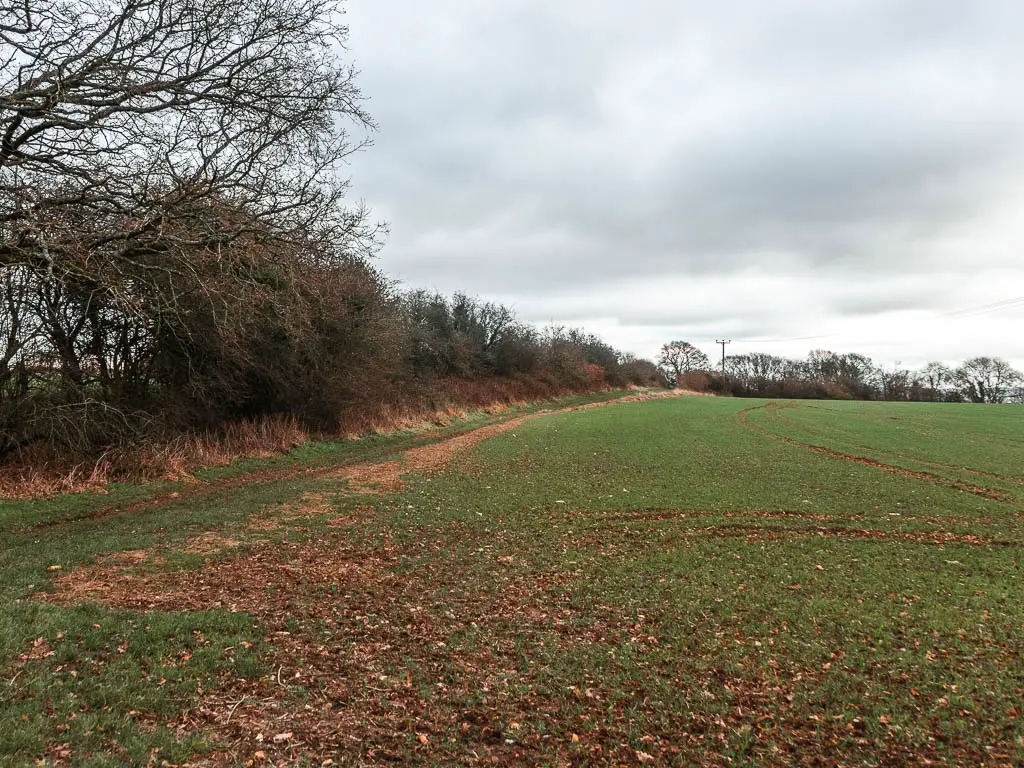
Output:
346 0 1024 367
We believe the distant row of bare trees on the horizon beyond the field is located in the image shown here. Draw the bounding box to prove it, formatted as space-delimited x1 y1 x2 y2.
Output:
657 341 1024 403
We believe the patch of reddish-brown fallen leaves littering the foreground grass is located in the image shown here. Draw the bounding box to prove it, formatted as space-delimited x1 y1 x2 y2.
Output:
36 507 1011 766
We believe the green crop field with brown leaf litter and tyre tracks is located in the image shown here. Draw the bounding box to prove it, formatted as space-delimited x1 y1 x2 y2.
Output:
0 393 1024 766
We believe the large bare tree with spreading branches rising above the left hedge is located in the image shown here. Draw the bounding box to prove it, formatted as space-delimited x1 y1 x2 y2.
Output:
0 0 385 379
